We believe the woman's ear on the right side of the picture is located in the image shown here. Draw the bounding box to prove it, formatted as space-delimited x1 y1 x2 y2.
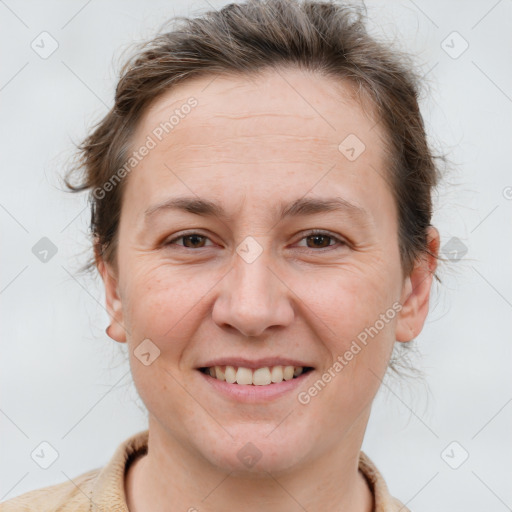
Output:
396 226 440 342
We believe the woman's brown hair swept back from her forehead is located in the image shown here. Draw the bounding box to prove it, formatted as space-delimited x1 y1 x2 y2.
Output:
66 0 438 282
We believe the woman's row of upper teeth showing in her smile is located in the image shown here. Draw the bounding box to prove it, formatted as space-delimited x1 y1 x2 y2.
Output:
207 366 304 386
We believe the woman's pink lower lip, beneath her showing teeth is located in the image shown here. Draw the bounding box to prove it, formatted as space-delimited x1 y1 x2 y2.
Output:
197 370 313 403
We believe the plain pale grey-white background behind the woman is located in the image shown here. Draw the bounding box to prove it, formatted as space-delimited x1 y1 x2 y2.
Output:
0 0 512 512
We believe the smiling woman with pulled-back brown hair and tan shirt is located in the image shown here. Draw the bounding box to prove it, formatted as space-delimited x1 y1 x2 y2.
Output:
2 0 439 512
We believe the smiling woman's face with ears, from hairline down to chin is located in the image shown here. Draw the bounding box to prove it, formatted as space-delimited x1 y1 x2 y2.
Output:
100 69 433 471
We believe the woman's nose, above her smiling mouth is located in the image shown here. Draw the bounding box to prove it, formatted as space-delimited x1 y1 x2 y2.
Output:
212 251 294 337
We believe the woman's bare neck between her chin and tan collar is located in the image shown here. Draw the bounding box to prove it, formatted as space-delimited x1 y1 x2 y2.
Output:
125 422 374 512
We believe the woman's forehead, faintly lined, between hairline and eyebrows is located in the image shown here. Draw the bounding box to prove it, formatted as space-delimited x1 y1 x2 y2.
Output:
128 65 385 212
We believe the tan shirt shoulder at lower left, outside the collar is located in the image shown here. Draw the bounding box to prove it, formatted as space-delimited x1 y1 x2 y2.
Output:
0 468 101 512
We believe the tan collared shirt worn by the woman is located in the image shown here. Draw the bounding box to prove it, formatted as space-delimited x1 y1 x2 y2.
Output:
0 430 410 512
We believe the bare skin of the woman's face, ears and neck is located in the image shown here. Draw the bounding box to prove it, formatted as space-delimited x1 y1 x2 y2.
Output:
97 69 439 512
